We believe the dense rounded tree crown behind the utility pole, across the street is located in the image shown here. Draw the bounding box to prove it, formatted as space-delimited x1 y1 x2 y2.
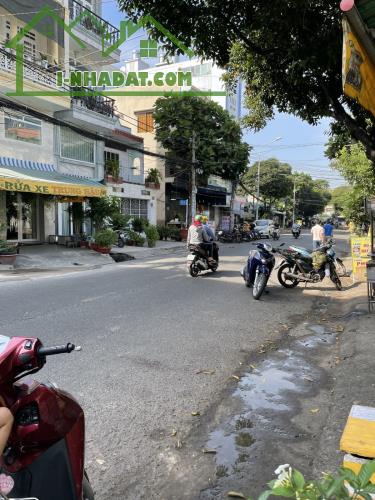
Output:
154 96 249 181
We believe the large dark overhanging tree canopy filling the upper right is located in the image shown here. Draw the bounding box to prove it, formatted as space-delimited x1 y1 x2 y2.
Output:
118 0 375 166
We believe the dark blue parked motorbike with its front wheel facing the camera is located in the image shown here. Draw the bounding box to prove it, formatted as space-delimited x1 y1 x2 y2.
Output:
241 243 275 300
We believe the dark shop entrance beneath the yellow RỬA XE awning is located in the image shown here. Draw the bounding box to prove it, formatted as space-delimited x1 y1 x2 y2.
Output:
6 191 39 242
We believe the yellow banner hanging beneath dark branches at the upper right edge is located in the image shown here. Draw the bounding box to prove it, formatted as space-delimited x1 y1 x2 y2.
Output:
342 19 375 116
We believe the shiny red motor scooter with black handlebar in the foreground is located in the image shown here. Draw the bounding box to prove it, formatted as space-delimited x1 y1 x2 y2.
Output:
0 335 94 500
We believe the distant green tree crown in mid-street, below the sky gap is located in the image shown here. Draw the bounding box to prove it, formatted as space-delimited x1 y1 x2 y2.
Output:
241 158 293 208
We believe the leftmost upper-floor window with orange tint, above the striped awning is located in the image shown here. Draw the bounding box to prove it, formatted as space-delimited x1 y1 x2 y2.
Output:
4 112 42 144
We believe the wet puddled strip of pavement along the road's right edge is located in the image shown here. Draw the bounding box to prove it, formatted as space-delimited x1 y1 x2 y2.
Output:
200 324 337 499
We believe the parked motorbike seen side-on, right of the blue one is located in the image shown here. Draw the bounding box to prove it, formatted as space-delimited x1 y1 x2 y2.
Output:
277 243 346 290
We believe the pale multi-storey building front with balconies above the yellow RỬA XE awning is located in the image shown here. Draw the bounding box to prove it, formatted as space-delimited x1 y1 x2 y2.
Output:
0 0 153 243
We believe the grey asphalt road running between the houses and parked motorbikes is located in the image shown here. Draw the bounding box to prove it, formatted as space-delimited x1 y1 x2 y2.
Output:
0 235 350 500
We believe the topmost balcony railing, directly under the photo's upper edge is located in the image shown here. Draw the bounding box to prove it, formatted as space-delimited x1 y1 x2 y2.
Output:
69 0 120 46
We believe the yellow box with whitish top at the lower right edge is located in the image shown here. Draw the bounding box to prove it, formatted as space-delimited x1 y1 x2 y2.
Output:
340 405 375 458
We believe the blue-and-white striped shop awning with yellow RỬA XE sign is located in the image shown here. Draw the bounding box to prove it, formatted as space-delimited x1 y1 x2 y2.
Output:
0 157 107 198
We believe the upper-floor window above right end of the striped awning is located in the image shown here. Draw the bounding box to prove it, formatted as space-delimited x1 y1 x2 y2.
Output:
60 127 95 163
